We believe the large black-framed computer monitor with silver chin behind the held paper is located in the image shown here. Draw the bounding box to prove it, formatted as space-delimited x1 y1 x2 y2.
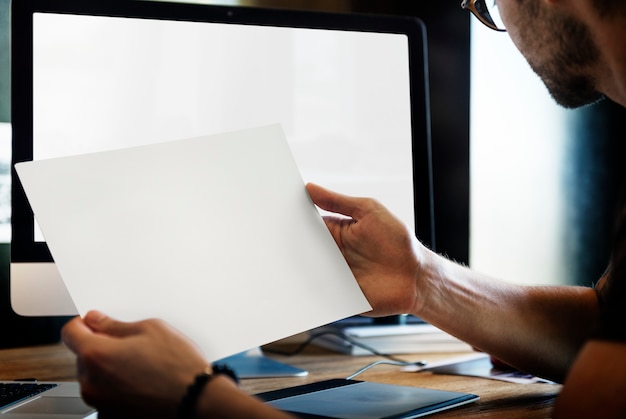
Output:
11 0 435 316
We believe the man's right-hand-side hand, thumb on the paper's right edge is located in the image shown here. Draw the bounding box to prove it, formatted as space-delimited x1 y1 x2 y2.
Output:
307 184 430 316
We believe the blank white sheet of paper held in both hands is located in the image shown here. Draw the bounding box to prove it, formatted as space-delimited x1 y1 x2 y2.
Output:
16 125 371 361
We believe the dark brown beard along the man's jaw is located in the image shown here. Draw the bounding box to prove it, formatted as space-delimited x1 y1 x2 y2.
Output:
528 12 604 109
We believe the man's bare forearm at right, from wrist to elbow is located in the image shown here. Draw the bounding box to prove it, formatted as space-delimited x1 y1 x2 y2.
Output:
414 256 598 381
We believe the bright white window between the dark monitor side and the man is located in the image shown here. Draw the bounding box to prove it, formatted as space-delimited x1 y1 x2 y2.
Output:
470 21 568 284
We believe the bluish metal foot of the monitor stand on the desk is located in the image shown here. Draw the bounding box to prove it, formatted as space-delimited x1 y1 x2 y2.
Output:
214 347 308 378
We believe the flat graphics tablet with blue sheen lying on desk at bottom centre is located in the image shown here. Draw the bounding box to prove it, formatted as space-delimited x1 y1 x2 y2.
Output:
257 379 479 419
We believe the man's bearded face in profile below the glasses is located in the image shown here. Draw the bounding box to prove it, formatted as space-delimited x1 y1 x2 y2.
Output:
497 0 602 108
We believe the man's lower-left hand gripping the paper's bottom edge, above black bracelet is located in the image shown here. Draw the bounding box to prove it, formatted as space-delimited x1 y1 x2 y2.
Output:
62 312 209 418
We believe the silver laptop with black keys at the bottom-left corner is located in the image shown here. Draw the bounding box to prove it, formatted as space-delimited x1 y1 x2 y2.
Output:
0 381 98 419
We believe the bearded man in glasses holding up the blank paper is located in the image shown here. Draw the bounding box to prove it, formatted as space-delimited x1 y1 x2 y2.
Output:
63 0 626 417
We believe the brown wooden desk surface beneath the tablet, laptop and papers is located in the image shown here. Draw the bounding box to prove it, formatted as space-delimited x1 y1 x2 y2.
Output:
0 344 560 418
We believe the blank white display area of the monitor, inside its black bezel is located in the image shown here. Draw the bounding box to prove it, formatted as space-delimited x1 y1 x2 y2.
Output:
33 13 414 236
